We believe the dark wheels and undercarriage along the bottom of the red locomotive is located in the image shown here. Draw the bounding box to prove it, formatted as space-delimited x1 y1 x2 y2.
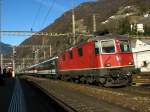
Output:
41 74 132 87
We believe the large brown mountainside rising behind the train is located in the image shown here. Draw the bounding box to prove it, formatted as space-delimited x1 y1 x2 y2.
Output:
17 0 150 62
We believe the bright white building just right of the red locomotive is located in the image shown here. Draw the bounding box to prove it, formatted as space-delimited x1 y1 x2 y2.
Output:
131 37 150 72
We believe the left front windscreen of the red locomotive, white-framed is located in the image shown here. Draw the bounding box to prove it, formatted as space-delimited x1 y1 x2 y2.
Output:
101 40 115 53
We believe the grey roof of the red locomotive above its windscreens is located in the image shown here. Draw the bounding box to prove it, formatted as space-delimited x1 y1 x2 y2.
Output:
88 34 128 41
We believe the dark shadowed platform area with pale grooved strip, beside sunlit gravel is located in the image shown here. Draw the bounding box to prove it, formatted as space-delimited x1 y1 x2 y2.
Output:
0 78 66 112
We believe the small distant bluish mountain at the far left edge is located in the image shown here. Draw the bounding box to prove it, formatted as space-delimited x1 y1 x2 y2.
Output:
0 42 12 55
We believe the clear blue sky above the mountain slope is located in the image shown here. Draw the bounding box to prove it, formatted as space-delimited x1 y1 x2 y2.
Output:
0 0 96 45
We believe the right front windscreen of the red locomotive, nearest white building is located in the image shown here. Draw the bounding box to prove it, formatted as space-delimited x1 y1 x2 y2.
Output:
120 40 131 52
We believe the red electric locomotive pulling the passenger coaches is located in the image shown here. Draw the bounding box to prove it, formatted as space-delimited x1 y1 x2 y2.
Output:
57 34 134 86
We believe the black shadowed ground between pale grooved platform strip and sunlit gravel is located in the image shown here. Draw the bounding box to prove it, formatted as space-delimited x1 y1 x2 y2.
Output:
20 79 71 112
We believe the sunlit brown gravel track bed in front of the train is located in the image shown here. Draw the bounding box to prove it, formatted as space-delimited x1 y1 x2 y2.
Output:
22 77 150 112
